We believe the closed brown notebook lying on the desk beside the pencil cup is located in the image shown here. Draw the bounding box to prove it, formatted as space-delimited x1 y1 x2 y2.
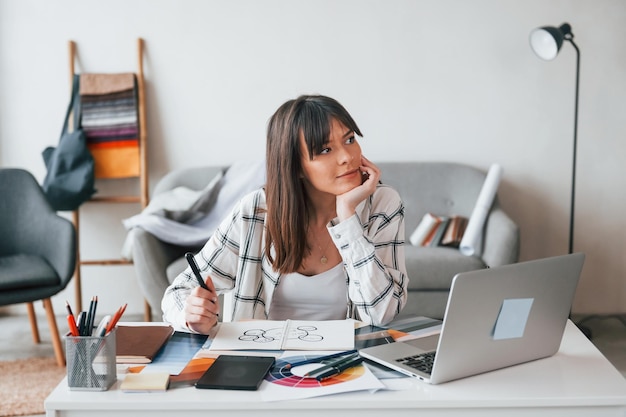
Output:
115 325 174 363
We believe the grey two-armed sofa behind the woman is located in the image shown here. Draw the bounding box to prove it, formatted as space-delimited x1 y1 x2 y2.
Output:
132 162 519 320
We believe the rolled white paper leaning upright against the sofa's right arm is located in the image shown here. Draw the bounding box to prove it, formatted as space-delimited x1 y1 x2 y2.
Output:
459 164 502 256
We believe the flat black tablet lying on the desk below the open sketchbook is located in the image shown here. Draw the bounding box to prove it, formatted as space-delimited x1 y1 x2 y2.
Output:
196 355 275 391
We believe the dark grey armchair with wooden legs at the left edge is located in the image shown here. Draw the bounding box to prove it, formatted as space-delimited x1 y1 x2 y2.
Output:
0 168 76 366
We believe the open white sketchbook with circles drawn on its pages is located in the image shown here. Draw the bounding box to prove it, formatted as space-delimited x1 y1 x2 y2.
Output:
209 320 354 351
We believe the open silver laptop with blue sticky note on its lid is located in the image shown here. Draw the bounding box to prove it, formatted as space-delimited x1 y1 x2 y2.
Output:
359 253 585 384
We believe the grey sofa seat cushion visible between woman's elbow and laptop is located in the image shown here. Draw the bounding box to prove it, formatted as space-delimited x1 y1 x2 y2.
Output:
405 245 486 291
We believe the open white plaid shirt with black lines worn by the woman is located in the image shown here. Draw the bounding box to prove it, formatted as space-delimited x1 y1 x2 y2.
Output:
162 184 408 329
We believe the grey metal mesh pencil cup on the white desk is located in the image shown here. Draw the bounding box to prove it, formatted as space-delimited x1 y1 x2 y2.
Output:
65 329 117 391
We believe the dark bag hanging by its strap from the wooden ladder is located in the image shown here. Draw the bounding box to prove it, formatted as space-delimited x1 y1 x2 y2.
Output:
42 74 96 210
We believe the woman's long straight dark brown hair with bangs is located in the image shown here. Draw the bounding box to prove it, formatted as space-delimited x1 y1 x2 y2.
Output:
265 95 363 273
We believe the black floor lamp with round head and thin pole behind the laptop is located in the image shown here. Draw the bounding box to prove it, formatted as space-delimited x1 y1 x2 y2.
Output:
530 23 580 253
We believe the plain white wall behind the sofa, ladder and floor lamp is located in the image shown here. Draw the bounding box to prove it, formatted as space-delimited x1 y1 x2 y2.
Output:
0 0 626 313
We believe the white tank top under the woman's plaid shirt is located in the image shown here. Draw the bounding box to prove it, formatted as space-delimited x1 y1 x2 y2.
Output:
269 263 348 320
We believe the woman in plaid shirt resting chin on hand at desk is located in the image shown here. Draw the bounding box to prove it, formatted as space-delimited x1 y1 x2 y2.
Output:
162 96 408 334
